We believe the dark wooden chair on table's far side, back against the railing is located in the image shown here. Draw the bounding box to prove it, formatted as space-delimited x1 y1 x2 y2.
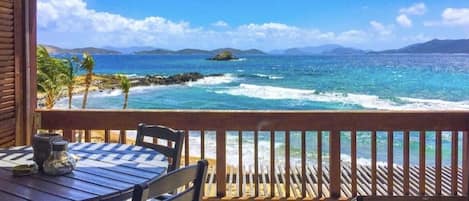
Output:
135 123 184 172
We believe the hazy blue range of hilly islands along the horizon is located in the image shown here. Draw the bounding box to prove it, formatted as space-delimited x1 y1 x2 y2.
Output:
39 39 469 56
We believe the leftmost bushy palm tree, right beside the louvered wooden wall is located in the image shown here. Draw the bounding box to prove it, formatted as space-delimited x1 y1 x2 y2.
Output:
37 46 66 109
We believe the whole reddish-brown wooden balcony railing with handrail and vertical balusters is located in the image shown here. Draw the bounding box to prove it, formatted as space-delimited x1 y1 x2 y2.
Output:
36 110 469 200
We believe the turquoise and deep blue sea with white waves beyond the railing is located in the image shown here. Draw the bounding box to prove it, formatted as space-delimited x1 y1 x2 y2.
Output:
57 54 469 166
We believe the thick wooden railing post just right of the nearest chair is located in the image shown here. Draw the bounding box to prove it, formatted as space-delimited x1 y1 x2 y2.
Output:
215 130 226 198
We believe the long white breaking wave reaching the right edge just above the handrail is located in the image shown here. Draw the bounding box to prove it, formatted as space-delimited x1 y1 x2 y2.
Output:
216 84 469 110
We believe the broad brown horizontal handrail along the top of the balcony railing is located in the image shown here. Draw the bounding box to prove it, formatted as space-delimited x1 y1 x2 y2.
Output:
36 110 469 131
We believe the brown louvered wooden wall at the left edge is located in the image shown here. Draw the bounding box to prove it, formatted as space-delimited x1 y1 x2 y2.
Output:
0 0 36 147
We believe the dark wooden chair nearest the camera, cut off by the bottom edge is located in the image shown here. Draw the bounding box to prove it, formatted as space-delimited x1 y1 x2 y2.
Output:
132 160 208 201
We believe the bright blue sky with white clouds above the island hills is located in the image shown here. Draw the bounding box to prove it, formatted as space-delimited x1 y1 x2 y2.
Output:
38 0 469 50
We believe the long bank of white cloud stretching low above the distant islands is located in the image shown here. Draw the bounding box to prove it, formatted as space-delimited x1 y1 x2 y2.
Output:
38 0 406 50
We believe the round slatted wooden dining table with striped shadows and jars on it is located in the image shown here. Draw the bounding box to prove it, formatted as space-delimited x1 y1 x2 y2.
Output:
0 143 168 201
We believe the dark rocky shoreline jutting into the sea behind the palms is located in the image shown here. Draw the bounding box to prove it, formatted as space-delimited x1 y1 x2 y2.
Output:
37 72 223 107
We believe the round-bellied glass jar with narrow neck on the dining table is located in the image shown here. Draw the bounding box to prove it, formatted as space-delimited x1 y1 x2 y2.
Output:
43 140 76 175
